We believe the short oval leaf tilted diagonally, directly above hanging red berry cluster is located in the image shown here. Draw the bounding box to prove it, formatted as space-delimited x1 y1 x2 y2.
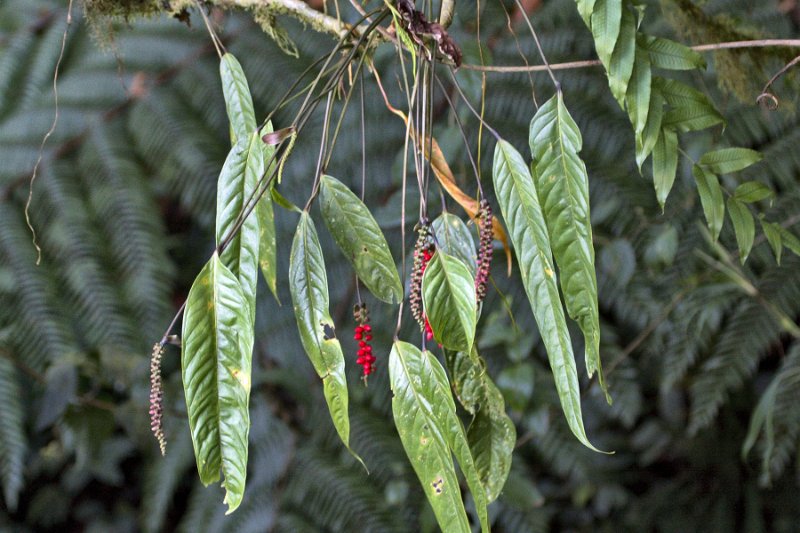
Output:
320 176 403 304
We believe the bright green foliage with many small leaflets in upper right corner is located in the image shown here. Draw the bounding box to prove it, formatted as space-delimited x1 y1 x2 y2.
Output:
576 0 796 263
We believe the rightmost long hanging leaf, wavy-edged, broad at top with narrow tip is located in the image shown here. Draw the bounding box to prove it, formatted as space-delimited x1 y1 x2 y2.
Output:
529 93 610 401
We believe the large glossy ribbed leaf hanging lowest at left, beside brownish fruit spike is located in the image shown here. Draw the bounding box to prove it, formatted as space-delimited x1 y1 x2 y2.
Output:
181 253 253 513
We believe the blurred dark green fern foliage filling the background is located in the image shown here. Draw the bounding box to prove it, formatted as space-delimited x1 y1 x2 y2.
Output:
0 0 800 533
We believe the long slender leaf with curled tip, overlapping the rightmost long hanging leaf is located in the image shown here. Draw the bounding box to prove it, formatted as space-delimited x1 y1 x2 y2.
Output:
493 136 596 450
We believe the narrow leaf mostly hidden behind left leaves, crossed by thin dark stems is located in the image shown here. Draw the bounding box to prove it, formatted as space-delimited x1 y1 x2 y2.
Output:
256 122 280 303
